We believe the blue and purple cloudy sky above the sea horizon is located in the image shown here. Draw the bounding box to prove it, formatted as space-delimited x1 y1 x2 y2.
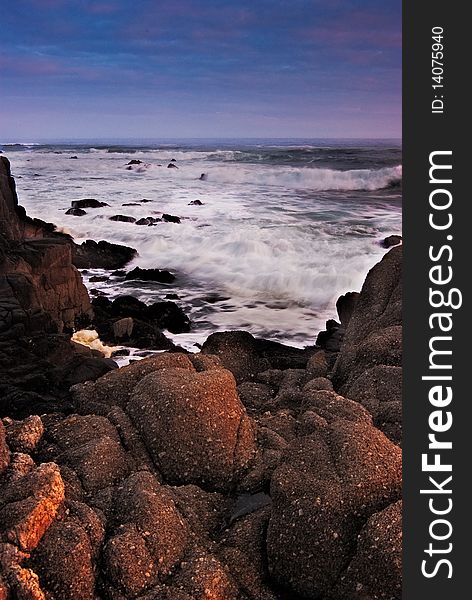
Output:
0 0 401 142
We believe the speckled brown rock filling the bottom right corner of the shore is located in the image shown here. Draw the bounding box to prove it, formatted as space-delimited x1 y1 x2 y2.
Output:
327 501 402 600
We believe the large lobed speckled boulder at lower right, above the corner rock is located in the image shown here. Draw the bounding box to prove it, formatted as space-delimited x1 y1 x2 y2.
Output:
267 422 401 598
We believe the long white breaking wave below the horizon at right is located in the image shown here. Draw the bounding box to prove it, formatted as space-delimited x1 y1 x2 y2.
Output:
203 165 402 191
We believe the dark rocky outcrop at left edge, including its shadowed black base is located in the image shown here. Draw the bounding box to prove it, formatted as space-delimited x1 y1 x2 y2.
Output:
0 156 116 418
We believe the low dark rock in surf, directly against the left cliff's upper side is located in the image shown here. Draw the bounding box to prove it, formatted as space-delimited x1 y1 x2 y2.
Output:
72 240 138 270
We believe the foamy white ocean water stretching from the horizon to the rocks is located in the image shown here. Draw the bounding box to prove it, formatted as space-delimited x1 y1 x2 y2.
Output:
0 139 402 350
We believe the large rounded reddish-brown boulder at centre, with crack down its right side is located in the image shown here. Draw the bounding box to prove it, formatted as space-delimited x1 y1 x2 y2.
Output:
127 369 255 490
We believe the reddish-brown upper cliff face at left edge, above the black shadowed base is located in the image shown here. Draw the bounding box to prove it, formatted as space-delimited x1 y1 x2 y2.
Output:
0 156 91 337
